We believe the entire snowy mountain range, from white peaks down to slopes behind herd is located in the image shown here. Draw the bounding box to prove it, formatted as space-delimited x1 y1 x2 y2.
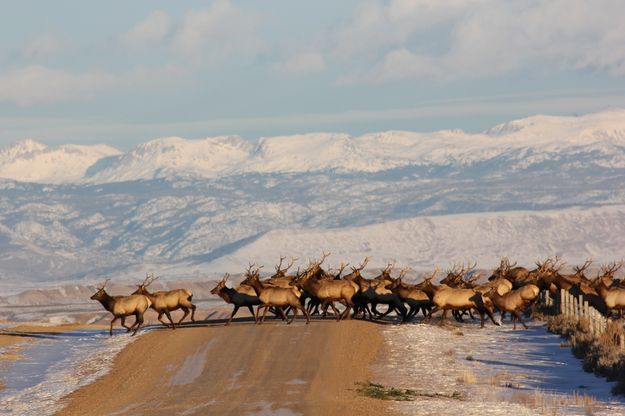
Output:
0 110 625 294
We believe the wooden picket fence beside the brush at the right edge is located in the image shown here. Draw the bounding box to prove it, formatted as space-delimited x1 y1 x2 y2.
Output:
552 289 625 350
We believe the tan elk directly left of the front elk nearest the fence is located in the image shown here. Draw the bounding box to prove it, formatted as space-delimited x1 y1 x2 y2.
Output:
420 272 499 328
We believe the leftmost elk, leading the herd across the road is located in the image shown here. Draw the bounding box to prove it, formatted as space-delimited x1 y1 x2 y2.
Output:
91 279 152 336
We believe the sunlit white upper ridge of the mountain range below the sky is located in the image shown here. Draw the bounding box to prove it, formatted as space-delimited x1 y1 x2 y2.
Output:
0 110 625 184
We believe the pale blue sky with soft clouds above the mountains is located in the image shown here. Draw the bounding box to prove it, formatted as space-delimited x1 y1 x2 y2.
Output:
0 0 625 149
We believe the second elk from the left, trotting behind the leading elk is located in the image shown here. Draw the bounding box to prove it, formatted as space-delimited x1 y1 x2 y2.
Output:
133 275 195 329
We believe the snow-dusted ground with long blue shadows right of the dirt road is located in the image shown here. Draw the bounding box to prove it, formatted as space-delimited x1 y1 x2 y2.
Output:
374 319 625 416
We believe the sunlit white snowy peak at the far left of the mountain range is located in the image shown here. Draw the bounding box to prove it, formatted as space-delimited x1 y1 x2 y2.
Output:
0 140 121 183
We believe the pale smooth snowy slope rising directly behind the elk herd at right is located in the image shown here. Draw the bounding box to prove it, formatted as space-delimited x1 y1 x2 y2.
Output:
209 206 625 272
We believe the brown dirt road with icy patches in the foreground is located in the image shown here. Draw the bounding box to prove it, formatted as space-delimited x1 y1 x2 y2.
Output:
59 320 389 416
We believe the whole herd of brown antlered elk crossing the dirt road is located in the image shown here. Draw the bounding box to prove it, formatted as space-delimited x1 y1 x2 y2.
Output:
91 252 625 335
